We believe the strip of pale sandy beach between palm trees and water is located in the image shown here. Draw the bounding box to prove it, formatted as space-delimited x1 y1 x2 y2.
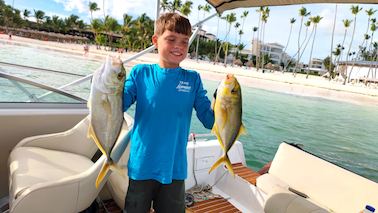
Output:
0 34 378 106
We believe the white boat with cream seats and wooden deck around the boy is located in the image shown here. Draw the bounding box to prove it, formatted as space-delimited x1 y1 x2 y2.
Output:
0 0 378 213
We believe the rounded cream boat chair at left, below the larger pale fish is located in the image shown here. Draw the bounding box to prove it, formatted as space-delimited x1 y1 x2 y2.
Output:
8 116 132 213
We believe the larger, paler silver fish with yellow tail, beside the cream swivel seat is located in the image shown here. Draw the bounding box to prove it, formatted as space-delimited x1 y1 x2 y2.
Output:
88 56 126 188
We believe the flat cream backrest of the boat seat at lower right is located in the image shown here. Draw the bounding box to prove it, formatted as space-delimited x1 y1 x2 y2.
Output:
269 143 378 213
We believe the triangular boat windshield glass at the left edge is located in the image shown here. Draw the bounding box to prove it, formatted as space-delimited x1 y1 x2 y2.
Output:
0 72 86 103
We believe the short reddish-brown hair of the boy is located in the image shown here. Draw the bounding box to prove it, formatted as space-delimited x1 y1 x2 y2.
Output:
155 13 192 36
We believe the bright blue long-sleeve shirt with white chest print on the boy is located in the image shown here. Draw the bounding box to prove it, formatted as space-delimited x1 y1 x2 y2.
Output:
123 64 214 184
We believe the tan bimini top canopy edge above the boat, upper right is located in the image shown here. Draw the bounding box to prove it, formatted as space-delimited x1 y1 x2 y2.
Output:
206 0 378 13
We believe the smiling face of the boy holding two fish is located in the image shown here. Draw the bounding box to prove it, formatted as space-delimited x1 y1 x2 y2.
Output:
152 30 189 68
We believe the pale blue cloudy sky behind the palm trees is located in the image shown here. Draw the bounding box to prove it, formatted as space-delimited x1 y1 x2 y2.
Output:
5 0 378 63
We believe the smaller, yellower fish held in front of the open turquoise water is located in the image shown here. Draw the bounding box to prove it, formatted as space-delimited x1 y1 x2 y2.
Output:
209 74 245 175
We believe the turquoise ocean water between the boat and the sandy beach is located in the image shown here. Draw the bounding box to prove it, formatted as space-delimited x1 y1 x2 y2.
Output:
0 43 378 182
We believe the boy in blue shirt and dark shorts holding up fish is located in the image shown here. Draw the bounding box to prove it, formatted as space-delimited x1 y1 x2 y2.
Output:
123 13 214 213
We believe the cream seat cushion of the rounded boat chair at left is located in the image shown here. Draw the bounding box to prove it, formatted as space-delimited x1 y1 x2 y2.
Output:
9 147 93 199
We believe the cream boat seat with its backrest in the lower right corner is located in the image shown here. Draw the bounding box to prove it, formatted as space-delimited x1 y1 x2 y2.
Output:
256 143 378 213
